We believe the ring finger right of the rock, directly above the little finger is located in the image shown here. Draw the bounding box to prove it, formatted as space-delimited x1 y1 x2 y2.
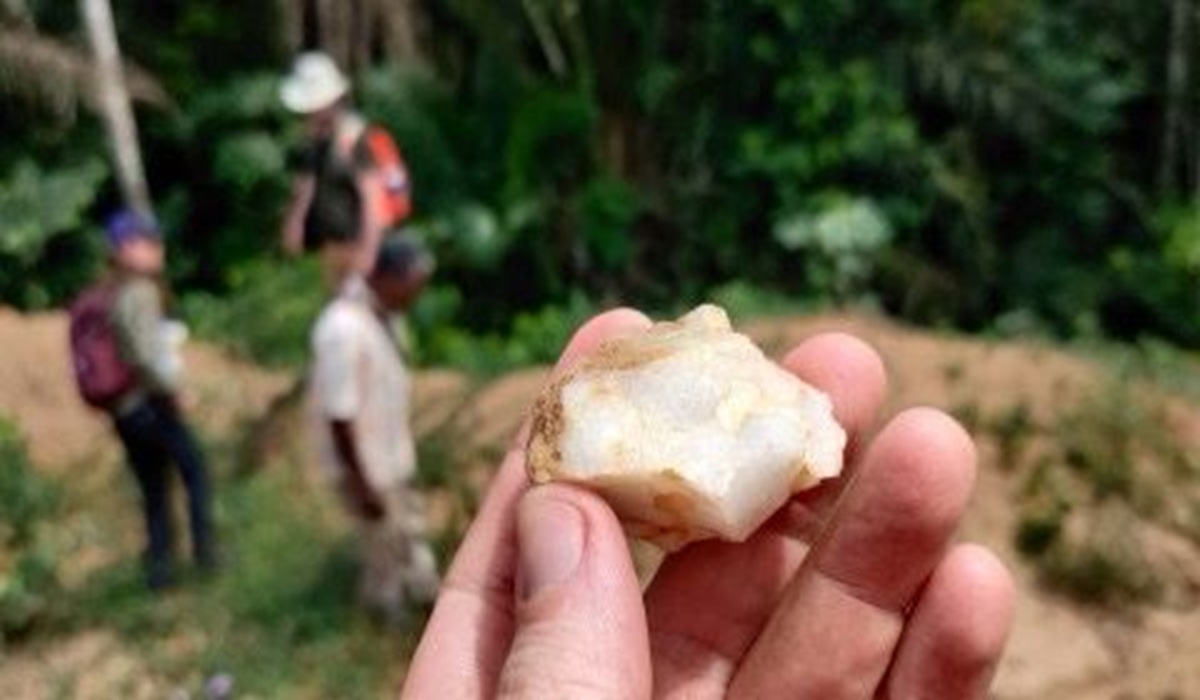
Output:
730 409 974 699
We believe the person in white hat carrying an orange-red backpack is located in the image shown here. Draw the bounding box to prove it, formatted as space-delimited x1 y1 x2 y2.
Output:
280 52 412 289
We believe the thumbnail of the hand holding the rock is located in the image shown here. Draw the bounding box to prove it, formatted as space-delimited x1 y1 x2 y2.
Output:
517 489 584 600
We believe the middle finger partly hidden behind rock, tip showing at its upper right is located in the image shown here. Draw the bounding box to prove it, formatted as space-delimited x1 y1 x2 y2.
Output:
646 334 886 698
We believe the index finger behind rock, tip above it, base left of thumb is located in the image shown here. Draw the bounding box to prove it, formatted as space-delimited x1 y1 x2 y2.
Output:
403 309 649 698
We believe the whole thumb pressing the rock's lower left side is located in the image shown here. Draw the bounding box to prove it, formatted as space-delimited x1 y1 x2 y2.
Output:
499 485 650 698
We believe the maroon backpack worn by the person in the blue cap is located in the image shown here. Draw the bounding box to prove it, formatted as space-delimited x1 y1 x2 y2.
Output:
70 282 137 408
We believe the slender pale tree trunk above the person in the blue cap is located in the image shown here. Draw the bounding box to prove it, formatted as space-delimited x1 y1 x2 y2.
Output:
79 0 152 215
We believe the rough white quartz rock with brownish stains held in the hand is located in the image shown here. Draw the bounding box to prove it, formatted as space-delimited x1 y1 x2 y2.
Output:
528 306 846 550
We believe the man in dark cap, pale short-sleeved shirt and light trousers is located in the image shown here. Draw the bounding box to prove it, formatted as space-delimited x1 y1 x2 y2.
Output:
312 235 439 626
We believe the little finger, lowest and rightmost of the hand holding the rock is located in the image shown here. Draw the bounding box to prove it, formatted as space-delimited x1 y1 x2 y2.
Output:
887 545 1014 700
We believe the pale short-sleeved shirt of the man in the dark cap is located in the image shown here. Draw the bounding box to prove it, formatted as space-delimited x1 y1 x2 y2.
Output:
311 276 416 491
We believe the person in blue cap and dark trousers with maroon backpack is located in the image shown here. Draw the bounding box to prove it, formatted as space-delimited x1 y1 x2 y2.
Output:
71 210 217 590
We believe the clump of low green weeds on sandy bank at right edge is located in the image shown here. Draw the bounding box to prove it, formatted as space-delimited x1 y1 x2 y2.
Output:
1003 373 1200 605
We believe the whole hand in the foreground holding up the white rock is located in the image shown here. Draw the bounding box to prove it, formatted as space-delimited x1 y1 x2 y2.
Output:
403 310 1013 700
